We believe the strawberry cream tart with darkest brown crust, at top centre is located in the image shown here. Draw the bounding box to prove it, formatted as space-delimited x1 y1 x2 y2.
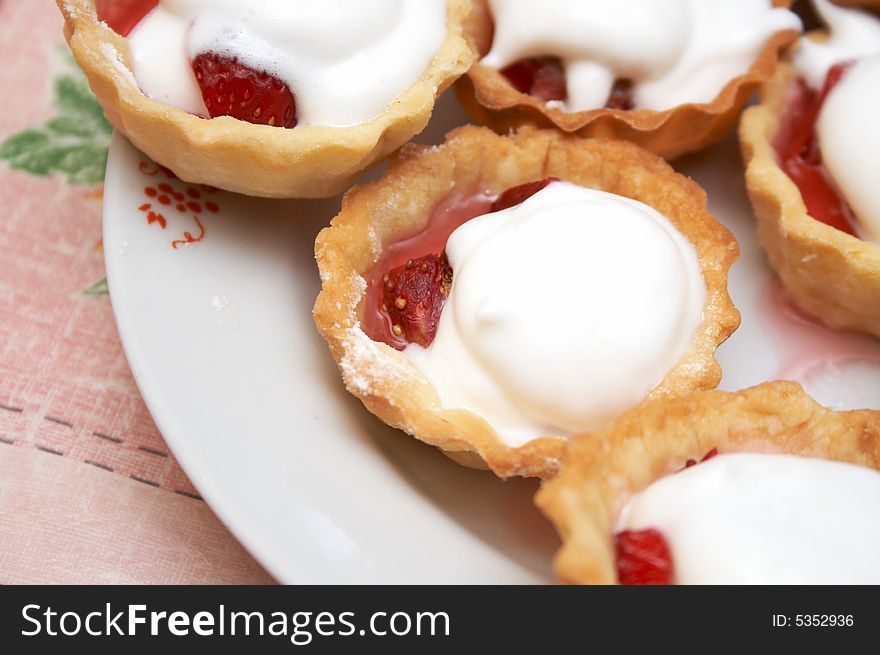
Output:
458 0 800 158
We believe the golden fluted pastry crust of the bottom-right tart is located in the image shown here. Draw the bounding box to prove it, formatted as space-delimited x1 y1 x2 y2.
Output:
535 382 880 584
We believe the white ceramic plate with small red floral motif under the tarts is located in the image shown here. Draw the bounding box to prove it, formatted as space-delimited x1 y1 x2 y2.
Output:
104 95 880 583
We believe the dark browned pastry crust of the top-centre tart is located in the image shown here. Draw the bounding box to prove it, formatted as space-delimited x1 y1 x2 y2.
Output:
456 0 797 160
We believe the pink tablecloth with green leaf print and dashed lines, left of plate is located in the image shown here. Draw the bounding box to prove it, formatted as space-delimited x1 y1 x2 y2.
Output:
0 0 271 584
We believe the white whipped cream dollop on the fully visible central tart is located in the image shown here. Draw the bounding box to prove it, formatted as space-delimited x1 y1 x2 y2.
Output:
404 182 706 447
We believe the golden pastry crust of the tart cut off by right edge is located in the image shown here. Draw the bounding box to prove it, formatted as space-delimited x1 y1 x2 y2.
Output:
739 54 880 337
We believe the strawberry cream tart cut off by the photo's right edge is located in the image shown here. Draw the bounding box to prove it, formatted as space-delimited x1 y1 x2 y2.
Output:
740 0 880 336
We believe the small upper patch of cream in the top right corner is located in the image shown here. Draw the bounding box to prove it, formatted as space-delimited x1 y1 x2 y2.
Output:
794 0 880 89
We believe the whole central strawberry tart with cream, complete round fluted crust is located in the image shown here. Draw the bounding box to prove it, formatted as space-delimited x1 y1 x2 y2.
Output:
315 127 739 477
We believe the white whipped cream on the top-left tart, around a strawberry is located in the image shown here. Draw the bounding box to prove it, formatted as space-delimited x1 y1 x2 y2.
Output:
129 0 446 127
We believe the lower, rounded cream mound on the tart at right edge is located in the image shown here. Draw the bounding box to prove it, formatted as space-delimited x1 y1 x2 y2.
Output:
816 53 880 243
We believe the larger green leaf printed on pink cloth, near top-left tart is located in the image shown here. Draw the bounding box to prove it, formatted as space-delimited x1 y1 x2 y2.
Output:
0 48 113 186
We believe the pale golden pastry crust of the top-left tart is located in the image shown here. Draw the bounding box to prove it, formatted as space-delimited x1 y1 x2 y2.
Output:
57 0 473 198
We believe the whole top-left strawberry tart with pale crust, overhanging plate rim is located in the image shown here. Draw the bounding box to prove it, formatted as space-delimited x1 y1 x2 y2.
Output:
58 0 472 197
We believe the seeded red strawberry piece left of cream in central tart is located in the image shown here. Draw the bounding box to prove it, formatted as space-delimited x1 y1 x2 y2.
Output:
382 252 452 348
